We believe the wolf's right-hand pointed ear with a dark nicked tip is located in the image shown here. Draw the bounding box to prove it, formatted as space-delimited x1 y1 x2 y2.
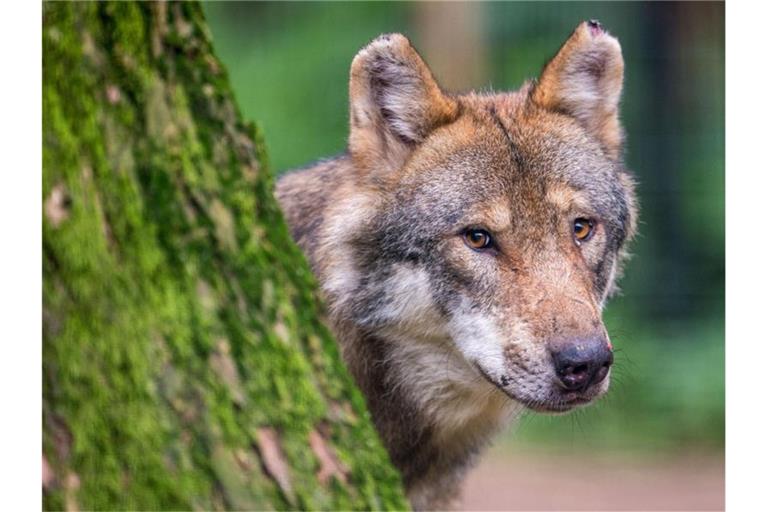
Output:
531 21 624 159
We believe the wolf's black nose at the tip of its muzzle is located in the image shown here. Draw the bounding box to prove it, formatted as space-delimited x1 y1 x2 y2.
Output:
552 336 613 391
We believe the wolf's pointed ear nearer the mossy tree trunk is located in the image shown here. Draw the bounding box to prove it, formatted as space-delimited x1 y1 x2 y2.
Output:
349 34 458 170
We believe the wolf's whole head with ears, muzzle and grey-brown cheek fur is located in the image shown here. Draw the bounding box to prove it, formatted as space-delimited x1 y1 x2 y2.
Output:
321 22 635 411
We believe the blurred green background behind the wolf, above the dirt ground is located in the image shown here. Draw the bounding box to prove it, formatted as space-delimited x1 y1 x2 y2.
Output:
205 2 725 454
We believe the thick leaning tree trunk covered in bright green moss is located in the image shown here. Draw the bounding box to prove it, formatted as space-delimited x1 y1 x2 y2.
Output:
43 2 407 510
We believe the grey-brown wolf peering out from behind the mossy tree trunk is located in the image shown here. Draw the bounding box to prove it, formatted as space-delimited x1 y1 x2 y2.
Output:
276 21 637 510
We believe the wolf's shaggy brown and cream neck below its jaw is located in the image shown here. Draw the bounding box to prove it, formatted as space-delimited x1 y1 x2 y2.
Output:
340 328 516 508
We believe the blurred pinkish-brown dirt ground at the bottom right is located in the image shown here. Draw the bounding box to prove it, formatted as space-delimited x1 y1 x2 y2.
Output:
464 453 725 511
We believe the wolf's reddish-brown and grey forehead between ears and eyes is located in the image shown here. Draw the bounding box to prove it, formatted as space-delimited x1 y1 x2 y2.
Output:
368 97 632 247
